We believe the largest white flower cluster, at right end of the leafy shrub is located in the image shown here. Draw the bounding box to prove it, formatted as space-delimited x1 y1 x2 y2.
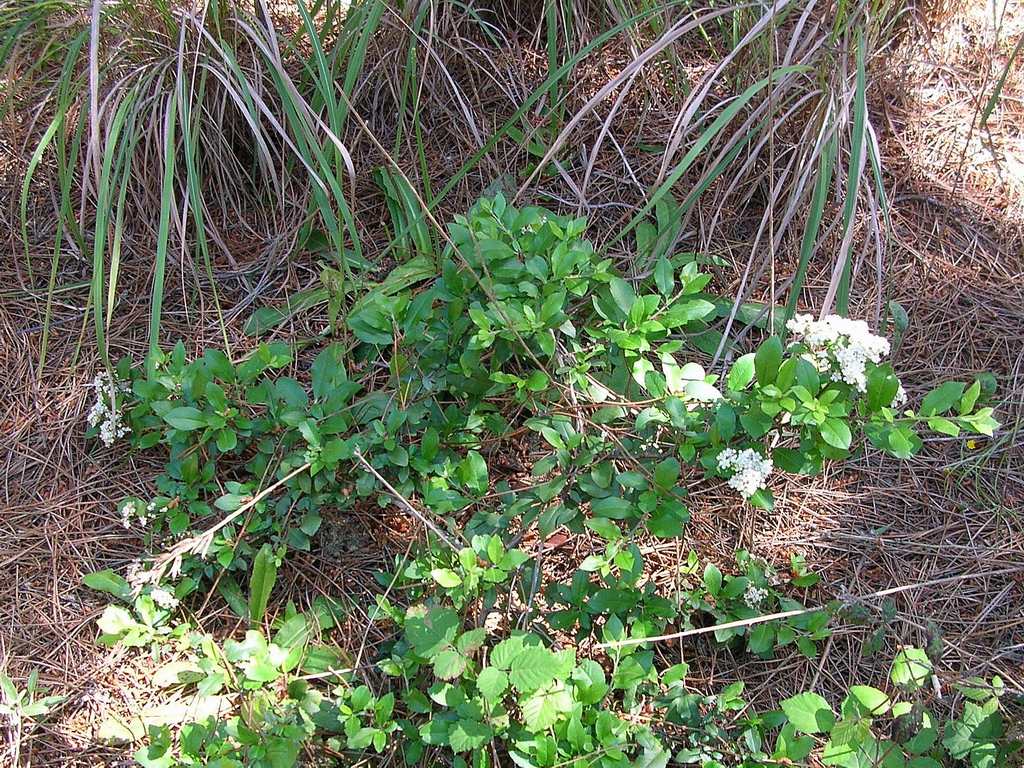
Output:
785 314 889 392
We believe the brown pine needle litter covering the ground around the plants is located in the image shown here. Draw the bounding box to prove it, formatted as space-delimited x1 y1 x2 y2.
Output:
0 1 1024 766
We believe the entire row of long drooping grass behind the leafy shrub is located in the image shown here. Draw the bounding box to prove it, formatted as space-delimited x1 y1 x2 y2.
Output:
9 0 913 366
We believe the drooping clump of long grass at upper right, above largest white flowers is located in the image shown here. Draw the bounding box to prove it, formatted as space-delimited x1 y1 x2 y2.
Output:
520 0 900 352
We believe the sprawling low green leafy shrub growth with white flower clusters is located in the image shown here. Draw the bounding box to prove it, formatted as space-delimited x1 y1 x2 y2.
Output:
79 197 1001 768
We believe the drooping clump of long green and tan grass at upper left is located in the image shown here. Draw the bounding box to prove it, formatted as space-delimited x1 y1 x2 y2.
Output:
0 0 372 368
